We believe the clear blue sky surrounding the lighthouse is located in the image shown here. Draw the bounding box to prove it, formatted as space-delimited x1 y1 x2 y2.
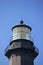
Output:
0 0 43 65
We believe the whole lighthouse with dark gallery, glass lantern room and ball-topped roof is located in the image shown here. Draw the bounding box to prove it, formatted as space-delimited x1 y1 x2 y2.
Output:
5 21 39 65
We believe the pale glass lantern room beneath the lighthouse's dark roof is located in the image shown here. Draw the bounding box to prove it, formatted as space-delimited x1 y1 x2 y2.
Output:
13 27 31 40
